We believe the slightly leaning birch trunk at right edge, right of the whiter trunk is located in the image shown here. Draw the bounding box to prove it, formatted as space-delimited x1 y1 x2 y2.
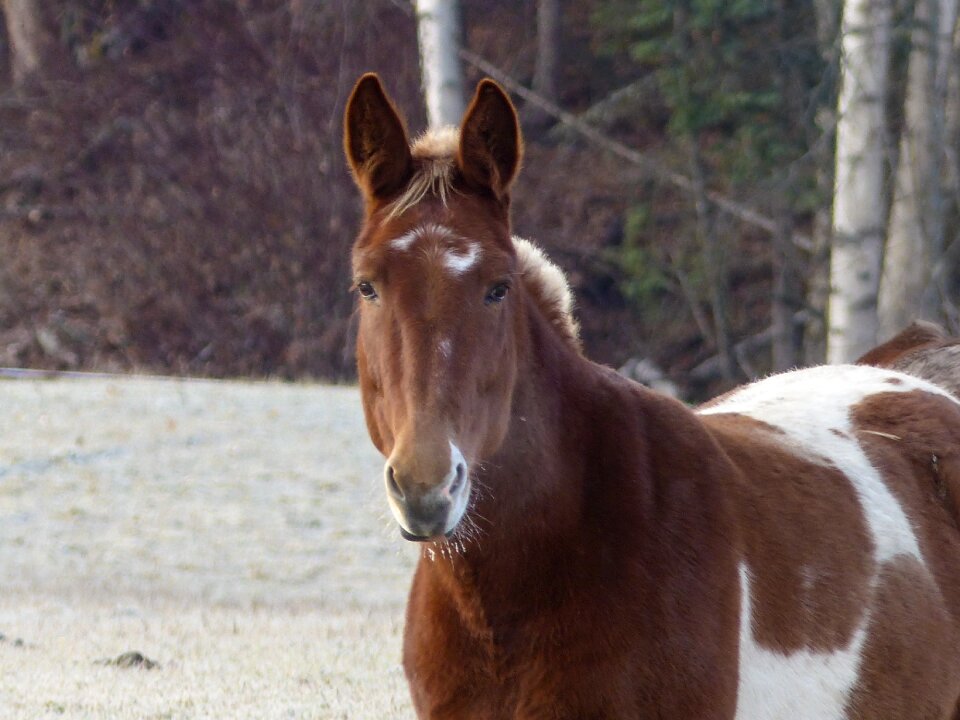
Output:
878 0 957 339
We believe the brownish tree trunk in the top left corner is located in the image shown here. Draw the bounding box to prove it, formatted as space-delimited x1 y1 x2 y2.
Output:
3 0 63 84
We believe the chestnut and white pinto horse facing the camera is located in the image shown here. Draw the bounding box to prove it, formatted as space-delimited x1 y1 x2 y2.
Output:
345 75 960 720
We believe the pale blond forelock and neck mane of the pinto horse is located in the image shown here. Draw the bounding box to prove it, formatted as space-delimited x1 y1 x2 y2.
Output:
388 130 581 351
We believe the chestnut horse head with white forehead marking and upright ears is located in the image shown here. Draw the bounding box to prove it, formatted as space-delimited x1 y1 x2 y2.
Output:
344 74 522 540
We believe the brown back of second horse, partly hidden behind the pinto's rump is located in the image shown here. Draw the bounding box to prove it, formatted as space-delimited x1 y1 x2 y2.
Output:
856 320 960 398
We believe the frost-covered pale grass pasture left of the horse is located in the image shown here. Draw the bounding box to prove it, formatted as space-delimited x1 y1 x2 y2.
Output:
0 378 416 720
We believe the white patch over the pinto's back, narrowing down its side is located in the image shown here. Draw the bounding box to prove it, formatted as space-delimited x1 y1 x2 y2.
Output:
698 365 950 571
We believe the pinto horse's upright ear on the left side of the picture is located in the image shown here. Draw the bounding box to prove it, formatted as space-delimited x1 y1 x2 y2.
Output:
343 73 413 203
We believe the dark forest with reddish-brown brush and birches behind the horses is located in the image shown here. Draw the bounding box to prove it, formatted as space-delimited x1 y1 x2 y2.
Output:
0 0 960 399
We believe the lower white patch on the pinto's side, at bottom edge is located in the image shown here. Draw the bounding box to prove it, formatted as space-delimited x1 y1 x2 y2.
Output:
736 563 868 720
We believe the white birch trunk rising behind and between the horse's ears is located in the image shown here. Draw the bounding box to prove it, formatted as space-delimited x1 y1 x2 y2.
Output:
416 0 465 128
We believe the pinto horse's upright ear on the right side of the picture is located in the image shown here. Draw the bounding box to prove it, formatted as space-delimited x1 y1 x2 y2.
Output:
458 79 523 200
